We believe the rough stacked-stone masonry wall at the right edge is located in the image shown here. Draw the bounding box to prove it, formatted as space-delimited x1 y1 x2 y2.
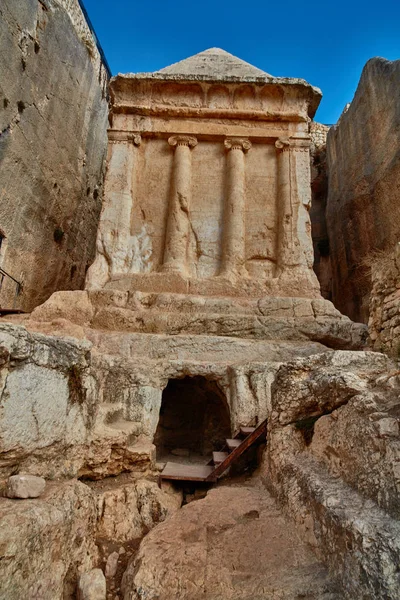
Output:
368 244 400 358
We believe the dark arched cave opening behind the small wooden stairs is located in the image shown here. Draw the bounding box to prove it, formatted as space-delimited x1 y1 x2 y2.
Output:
154 376 231 464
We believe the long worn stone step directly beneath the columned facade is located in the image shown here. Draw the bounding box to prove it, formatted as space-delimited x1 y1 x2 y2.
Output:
24 290 367 349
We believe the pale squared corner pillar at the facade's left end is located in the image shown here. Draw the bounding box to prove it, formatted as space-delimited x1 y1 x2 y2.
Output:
86 131 141 289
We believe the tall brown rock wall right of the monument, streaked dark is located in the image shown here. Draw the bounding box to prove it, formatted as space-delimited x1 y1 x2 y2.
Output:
326 58 400 322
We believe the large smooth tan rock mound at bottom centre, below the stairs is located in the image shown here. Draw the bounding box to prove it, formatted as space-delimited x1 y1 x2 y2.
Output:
122 484 342 600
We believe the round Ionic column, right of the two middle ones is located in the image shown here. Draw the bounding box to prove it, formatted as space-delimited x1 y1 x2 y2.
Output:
221 138 251 277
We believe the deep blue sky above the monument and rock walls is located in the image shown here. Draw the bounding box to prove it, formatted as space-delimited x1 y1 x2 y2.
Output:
83 0 400 123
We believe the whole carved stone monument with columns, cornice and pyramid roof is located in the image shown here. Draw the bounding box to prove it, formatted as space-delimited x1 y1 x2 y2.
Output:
87 49 320 297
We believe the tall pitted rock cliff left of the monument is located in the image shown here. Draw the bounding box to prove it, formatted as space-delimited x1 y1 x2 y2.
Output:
0 0 108 310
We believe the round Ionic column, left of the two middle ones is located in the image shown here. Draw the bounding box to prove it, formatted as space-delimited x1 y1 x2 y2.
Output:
162 135 197 275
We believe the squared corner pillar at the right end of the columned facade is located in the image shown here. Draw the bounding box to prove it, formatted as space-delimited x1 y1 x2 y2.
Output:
275 138 313 276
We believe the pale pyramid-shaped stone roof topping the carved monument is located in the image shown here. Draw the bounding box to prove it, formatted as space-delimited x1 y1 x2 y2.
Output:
156 48 271 80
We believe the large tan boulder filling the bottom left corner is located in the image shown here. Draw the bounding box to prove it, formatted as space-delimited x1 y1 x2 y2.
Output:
0 481 98 600
